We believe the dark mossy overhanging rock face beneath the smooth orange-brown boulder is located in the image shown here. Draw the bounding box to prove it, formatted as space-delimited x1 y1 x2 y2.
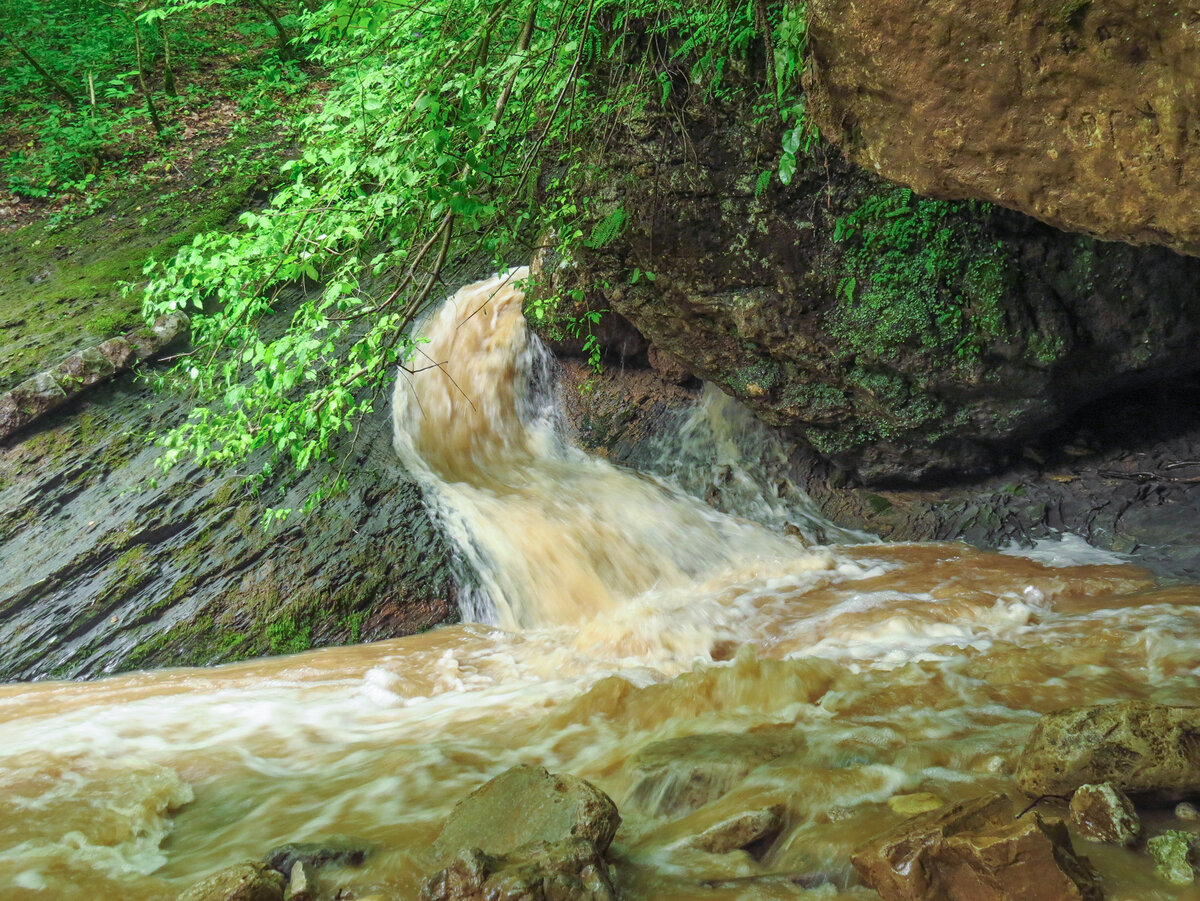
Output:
544 76 1200 483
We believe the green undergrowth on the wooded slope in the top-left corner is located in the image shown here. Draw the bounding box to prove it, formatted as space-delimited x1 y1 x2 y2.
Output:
0 0 309 199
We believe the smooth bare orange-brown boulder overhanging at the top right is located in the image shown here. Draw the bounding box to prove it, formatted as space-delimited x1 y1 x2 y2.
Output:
806 0 1200 254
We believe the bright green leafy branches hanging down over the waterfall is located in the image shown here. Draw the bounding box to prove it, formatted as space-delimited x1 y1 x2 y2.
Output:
138 0 803 494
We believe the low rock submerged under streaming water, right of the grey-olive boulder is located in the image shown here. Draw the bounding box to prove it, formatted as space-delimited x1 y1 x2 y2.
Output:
629 732 803 816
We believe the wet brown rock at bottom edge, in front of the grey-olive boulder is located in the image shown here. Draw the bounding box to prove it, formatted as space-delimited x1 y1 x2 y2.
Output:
421 837 618 901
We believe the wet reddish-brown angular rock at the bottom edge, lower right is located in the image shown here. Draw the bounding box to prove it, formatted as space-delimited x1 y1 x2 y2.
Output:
851 794 1103 901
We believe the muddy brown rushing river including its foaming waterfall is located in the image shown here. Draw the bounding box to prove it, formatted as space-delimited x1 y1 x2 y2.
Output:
0 270 1200 901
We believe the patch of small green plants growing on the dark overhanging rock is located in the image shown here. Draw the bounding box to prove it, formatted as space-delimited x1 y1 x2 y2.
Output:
830 188 1009 366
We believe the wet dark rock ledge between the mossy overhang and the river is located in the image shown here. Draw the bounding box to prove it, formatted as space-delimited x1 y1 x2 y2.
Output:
554 360 1200 582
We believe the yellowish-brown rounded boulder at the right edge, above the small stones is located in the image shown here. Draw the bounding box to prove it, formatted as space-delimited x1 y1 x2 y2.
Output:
1016 701 1200 799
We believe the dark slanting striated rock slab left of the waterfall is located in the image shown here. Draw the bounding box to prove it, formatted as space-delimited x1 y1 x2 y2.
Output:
0 362 457 680
